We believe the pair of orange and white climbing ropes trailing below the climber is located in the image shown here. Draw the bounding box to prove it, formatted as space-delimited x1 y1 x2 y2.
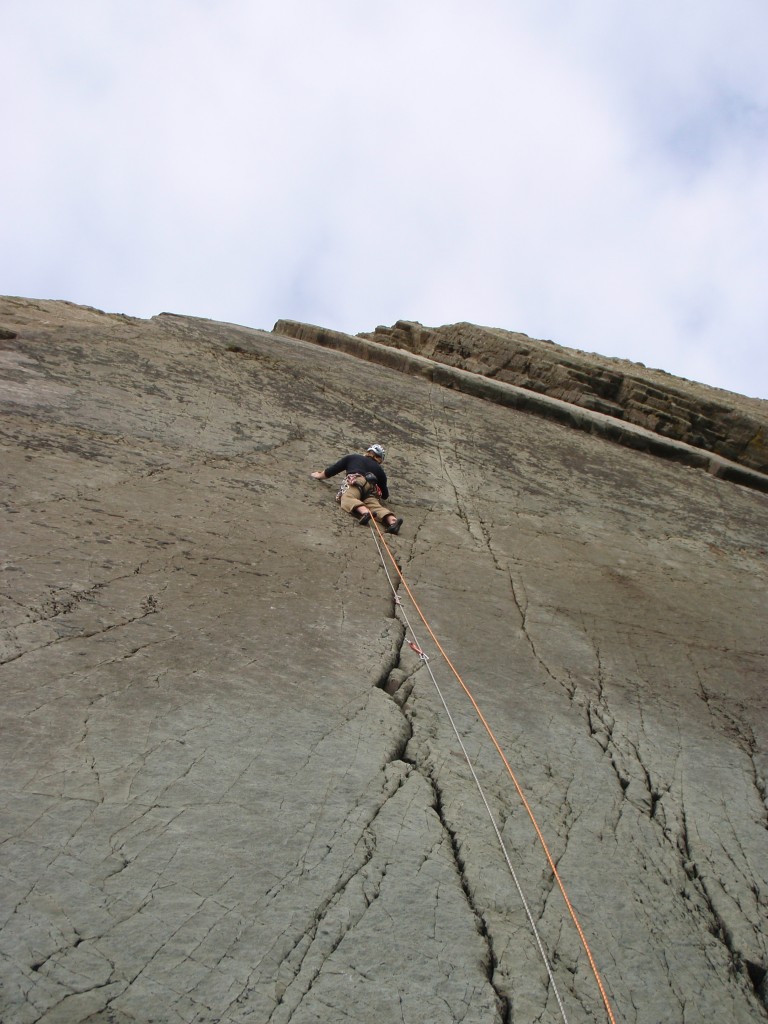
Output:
371 519 616 1024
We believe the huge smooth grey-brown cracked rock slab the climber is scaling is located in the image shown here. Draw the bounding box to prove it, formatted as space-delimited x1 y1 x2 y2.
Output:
0 299 768 1024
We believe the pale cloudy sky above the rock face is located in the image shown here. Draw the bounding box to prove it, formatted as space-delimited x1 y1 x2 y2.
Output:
0 0 768 398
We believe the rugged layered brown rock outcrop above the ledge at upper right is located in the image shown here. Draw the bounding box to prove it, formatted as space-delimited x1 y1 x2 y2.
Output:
360 321 768 473
